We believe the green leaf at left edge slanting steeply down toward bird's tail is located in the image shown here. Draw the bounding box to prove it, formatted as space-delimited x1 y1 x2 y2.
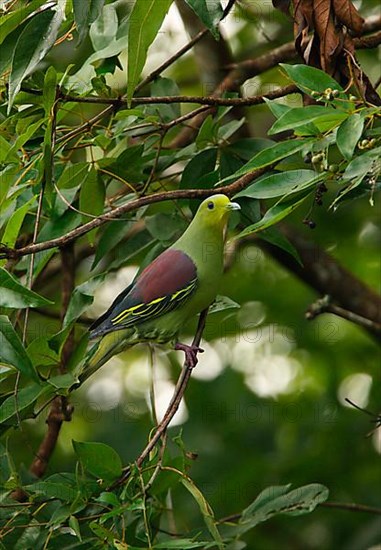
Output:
0 315 39 381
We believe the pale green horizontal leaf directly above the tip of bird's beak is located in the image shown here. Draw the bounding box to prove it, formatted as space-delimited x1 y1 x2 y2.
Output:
234 170 324 199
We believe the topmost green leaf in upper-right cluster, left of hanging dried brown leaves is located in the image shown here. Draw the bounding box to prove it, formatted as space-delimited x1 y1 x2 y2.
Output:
280 63 343 95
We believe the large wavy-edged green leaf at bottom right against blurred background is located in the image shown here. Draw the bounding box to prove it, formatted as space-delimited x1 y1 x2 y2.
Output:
238 483 328 534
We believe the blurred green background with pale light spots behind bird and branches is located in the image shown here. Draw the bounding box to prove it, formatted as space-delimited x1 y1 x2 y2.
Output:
3 1 381 550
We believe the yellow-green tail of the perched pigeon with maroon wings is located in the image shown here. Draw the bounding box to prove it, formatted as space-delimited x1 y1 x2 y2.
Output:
79 329 131 383
